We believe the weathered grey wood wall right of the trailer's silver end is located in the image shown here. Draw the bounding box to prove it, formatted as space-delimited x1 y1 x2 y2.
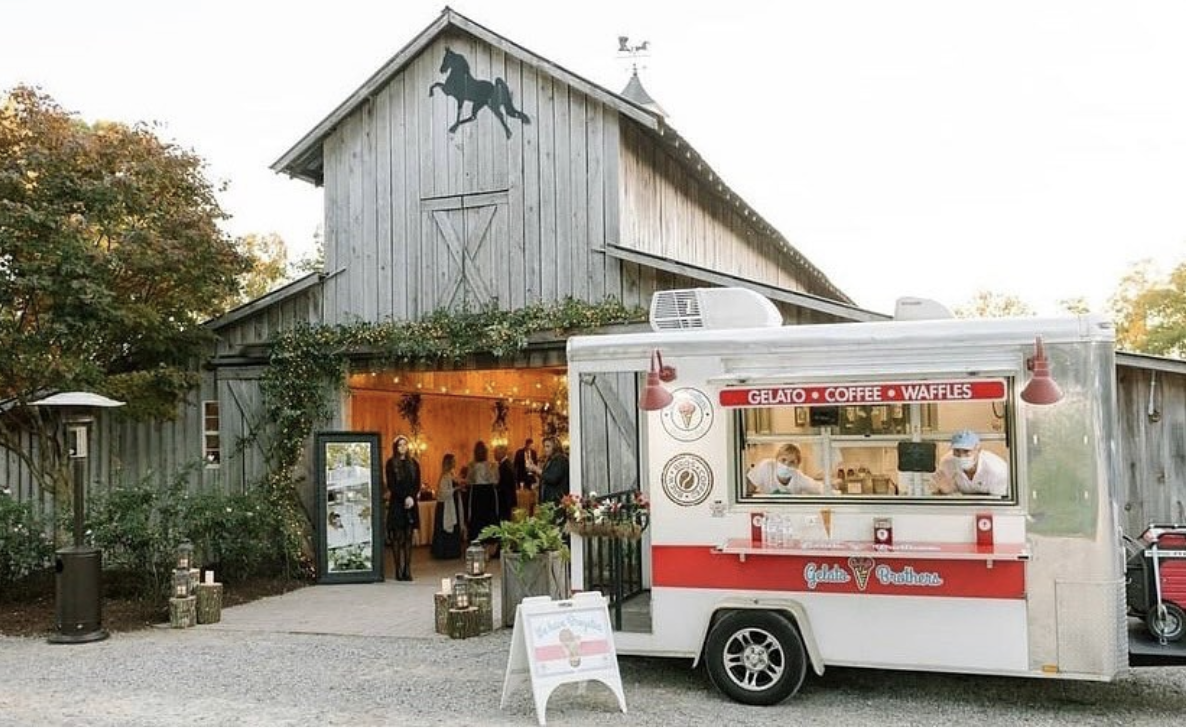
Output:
1116 366 1186 536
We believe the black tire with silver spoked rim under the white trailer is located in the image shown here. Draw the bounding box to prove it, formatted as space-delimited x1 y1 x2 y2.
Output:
704 609 808 705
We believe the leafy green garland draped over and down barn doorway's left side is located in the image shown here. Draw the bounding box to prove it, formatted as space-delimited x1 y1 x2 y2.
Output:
261 298 646 571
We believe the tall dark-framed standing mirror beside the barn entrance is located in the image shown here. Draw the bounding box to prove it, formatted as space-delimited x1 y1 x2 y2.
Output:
314 432 383 583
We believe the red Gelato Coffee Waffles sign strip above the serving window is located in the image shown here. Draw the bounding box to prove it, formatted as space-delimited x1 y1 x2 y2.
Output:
721 379 1007 407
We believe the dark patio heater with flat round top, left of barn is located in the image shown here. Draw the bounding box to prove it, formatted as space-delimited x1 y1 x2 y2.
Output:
30 391 123 644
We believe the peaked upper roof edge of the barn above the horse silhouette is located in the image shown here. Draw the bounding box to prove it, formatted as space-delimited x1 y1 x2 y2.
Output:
272 7 853 318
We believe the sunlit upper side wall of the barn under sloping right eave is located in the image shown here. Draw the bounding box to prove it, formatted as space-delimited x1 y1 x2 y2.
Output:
618 124 827 301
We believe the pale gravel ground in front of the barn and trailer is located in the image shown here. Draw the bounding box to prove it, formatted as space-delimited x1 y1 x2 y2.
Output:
0 627 1186 726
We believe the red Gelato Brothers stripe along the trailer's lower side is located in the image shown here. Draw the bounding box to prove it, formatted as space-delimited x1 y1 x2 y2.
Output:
651 545 1026 599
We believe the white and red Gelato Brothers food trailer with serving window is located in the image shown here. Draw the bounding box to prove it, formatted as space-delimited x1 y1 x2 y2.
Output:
568 289 1128 704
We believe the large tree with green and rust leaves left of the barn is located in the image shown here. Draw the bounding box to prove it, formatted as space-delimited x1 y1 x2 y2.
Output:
0 87 248 519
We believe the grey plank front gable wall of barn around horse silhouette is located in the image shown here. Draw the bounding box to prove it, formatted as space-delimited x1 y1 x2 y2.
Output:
324 36 630 323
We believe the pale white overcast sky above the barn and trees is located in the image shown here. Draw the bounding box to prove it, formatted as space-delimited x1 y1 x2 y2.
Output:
0 0 1186 314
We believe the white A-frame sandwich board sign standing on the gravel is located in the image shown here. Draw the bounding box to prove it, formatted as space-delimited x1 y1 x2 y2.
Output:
499 592 626 726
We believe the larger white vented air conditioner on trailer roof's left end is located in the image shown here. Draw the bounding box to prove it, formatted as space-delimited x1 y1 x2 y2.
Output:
651 288 783 331
